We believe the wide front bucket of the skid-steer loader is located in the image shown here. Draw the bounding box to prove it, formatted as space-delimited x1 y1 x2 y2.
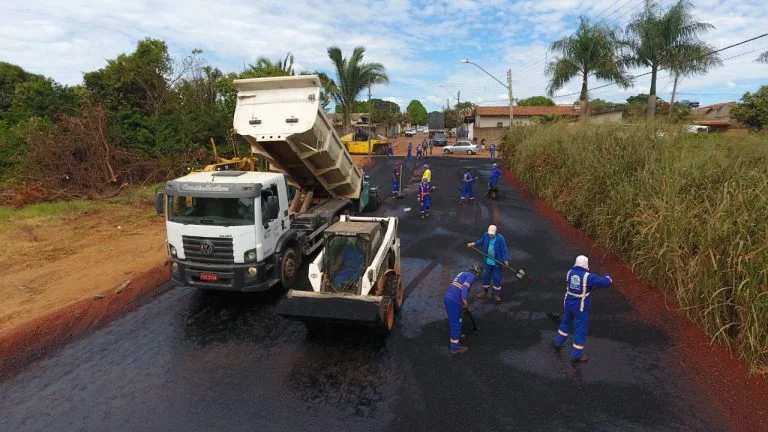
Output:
275 290 384 325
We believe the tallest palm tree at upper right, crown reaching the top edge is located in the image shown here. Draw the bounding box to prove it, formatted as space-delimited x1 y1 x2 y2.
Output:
626 0 714 120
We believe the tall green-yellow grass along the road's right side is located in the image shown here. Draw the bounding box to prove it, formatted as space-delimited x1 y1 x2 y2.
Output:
502 125 768 372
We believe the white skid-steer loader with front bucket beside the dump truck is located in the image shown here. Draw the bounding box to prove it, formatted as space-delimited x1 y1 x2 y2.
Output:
276 216 404 335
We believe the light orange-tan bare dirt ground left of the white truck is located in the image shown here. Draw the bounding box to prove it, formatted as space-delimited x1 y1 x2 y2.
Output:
0 205 166 339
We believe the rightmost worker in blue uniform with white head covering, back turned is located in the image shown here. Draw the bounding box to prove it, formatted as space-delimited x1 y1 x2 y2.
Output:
553 255 613 363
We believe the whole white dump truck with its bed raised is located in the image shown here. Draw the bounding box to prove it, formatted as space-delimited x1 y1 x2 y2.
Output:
155 75 379 291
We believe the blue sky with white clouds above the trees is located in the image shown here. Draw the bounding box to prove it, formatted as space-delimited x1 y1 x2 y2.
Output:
0 0 768 111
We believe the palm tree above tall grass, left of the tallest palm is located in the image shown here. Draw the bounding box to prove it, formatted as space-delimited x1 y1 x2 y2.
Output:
547 16 632 115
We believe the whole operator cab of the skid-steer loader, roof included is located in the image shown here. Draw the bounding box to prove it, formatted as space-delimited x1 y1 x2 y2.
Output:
322 222 382 294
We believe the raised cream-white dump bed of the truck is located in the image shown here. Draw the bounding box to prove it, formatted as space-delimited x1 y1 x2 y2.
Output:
234 75 363 199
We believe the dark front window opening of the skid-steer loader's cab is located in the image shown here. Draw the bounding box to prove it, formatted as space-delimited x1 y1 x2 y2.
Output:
325 236 368 292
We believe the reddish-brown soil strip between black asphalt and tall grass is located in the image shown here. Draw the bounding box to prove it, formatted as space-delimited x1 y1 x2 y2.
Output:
503 170 768 431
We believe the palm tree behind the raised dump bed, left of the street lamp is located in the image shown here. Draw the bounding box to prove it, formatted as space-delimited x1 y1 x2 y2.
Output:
328 46 389 133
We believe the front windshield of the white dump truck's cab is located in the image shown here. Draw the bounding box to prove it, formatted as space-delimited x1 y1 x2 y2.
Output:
168 196 255 226
